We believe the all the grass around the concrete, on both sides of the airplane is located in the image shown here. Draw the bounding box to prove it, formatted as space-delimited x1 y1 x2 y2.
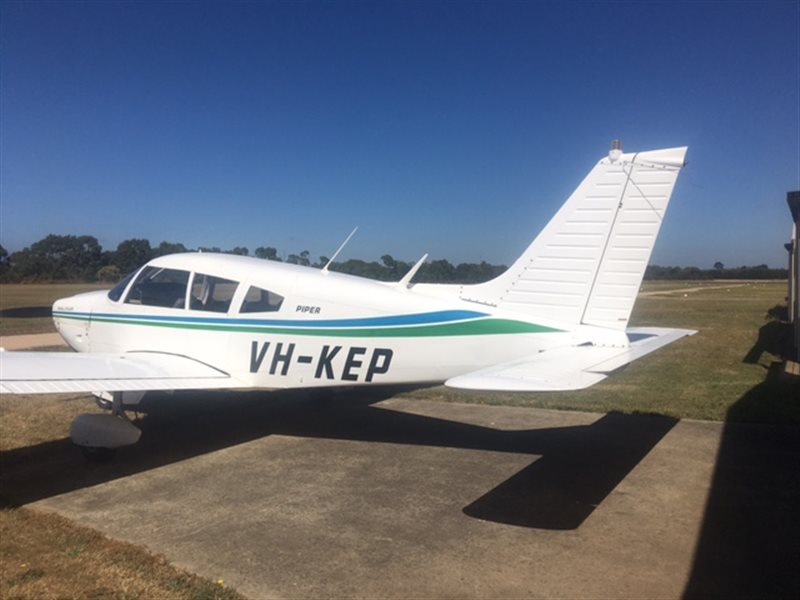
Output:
0 282 800 599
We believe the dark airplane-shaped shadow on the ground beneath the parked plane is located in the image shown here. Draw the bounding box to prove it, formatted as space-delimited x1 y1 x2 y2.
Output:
0 388 677 530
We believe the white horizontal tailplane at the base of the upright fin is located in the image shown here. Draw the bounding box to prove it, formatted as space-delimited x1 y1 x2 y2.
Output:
445 327 696 392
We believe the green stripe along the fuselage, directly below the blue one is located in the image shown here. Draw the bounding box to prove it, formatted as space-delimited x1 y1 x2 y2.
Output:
60 315 560 337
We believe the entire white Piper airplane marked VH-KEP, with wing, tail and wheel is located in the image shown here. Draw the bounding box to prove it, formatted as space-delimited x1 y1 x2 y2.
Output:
0 146 694 453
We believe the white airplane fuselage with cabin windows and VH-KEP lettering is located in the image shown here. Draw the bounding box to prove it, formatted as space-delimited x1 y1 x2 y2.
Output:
53 253 580 389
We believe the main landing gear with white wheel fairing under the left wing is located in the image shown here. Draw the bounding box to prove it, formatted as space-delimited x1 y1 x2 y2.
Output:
69 392 144 462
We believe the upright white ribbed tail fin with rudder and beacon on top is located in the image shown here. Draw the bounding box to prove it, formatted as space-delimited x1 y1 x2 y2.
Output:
460 145 686 331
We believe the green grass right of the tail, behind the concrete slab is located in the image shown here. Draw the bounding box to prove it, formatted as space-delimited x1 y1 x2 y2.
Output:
406 281 800 423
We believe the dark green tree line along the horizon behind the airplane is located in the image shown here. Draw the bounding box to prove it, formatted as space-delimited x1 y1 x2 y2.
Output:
0 234 788 283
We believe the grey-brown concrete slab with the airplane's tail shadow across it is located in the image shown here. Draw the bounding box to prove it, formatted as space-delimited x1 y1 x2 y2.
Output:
21 399 792 598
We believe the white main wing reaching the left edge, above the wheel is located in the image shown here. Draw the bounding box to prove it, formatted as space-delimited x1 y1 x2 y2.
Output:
0 351 246 394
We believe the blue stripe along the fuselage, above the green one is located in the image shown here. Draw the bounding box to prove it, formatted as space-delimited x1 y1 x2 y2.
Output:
53 310 489 328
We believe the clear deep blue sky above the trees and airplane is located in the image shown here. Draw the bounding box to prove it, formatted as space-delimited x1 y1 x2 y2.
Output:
0 0 800 267
